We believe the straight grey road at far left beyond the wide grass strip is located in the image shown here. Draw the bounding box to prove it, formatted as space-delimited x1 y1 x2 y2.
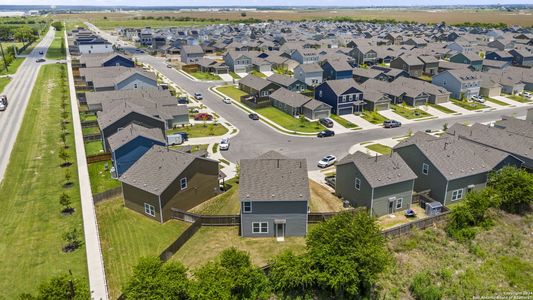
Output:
0 29 55 182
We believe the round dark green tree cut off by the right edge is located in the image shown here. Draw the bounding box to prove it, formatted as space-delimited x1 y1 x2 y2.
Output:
488 166 533 213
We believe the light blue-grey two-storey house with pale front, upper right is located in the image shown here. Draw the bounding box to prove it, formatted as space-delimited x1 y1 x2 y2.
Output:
431 69 481 99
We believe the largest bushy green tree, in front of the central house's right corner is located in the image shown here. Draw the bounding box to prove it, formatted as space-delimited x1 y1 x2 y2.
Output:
307 210 391 298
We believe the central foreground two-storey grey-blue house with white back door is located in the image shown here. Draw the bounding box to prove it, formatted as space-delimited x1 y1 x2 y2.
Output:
239 151 311 240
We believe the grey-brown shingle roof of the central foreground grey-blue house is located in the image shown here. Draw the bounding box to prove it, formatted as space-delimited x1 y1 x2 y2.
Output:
239 151 311 201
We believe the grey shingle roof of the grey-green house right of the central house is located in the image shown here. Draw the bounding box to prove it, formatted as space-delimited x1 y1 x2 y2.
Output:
337 151 417 188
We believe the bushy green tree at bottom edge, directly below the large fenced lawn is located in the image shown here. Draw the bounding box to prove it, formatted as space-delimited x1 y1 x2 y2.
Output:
123 257 189 300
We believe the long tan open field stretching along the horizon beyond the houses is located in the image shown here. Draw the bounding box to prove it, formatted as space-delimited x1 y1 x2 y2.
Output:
57 9 533 28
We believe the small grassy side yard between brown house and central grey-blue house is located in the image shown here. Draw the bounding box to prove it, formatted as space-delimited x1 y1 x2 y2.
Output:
190 178 237 215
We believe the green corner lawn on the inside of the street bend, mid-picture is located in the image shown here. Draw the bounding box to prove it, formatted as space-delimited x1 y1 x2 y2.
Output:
255 106 325 133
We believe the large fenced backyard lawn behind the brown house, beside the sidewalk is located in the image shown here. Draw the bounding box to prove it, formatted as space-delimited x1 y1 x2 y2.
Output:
96 198 188 299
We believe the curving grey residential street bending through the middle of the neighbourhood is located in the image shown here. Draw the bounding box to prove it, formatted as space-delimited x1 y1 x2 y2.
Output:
85 24 527 170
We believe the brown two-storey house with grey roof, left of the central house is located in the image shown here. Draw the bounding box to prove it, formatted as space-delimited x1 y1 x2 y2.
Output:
119 145 219 223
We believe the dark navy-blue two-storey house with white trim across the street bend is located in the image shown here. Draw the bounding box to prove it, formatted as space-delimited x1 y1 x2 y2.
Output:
315 78 365 115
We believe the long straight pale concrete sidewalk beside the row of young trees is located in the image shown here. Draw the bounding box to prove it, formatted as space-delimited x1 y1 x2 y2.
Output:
65 32 108 300
